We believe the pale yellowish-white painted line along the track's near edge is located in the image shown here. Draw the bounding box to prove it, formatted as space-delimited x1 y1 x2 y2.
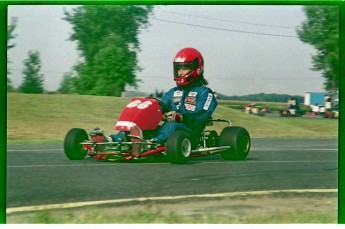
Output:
6 189 338 214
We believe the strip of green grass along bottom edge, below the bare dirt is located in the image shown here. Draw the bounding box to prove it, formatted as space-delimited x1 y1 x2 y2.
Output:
7 210 337 224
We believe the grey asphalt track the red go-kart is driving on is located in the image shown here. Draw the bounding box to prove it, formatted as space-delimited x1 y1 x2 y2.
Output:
7 139 338 212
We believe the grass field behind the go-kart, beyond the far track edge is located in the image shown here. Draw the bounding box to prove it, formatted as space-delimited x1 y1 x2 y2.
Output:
7 93 338 144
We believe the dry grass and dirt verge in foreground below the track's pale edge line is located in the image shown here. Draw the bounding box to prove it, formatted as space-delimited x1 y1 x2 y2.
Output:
7 193 337 224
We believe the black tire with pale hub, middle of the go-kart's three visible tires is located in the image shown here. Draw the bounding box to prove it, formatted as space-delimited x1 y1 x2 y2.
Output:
166 130 192 164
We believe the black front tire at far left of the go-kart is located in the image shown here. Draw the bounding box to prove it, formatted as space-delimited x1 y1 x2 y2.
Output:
64 128 89 160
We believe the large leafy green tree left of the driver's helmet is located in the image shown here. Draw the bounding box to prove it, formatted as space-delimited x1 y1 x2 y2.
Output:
64 5 152 96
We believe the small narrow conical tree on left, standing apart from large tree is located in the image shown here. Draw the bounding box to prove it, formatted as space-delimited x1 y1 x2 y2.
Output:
19 51 44 94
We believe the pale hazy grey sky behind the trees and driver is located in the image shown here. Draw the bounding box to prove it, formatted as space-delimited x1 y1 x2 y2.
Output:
8 5 324 96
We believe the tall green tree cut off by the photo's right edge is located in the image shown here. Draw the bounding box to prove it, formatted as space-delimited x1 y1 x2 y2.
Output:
297 5 339 95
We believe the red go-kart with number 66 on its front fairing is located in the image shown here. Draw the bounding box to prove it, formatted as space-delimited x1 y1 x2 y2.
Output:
64 98 251 164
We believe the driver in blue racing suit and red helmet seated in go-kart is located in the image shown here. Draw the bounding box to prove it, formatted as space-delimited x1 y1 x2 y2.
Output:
90 48 217 143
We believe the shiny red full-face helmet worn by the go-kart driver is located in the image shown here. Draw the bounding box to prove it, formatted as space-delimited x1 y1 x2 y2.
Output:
174 48 204 86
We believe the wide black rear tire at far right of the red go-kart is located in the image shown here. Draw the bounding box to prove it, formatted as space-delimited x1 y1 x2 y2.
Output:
219 126 250 160
